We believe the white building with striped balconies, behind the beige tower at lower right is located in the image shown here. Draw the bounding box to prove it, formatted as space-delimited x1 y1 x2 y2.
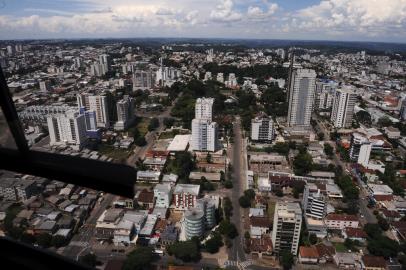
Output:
302 184 327 220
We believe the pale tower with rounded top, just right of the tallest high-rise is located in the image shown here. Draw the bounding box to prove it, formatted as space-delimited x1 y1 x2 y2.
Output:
331 86 357 128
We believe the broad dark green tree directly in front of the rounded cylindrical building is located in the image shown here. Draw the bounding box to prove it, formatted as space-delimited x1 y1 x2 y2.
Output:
167 239 201 262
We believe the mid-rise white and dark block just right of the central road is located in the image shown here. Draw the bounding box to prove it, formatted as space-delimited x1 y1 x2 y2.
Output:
251 114 274 142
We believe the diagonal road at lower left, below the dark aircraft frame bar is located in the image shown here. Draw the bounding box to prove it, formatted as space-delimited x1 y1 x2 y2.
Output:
62 194 116 259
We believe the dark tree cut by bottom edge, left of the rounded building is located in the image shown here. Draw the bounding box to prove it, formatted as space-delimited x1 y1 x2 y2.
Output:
123 247 154 270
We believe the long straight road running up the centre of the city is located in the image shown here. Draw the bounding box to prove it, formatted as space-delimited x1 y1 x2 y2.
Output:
228 117 245 261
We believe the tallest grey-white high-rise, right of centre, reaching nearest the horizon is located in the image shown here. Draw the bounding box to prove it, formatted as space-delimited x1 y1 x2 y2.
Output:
288 69 316 127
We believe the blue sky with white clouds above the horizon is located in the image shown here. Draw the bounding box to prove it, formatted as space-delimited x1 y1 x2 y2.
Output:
0 0 406 43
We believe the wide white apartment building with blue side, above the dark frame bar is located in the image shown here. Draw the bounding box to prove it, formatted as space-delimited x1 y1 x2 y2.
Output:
47 110 86 148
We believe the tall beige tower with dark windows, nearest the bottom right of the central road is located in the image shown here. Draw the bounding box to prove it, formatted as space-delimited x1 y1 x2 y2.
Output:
272 202 302 255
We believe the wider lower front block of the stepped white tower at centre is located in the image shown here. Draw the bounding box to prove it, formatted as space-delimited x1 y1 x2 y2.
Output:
191 119 218 152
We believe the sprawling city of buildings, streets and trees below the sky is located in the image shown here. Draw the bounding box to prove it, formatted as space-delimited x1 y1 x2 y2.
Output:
0 1 406 270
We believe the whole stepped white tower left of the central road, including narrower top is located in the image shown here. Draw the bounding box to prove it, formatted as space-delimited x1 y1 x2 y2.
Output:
191 98 218 152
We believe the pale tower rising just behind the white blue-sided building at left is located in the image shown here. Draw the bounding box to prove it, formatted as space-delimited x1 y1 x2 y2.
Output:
77 93 110 128
